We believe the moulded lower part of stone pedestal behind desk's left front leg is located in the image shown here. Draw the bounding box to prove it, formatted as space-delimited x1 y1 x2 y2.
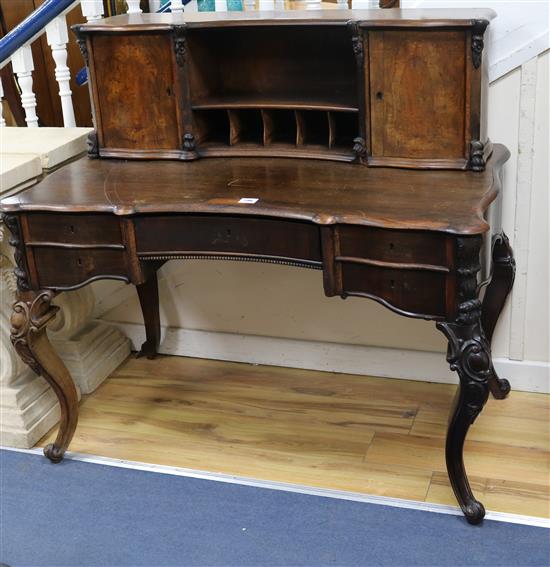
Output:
0 225 130 448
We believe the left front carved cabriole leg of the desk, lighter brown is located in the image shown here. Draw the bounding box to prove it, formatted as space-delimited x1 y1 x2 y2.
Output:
11 291 78 463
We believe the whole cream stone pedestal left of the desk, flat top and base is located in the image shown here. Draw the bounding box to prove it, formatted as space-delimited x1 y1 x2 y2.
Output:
0 128 130 448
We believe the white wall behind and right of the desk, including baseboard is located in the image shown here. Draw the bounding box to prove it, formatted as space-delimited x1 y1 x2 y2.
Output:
92 16 550 391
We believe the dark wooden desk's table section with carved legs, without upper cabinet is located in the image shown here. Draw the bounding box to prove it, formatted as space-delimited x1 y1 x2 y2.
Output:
2 145 514 523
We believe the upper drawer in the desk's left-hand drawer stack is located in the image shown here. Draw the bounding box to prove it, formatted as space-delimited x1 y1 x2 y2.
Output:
27 213 122 245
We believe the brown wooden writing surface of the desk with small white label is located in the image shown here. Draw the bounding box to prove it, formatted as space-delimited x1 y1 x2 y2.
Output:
1 144 509 234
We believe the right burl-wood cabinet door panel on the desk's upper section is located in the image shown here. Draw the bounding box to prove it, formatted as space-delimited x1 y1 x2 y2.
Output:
369 30 466 160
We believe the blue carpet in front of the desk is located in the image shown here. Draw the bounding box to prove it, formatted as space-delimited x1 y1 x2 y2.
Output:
0 451 550 567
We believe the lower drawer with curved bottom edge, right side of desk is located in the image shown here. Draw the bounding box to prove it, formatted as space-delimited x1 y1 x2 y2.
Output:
342 264 446 316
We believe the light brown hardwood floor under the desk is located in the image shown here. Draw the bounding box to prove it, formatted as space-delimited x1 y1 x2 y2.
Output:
36 357 550 517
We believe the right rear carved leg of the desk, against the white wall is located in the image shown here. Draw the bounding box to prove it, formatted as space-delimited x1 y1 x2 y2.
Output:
481 233 516 400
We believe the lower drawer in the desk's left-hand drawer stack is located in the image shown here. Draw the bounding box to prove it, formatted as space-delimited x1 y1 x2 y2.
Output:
33 247 128 288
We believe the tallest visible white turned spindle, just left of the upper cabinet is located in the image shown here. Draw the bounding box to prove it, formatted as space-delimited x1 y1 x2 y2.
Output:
46 16 76 128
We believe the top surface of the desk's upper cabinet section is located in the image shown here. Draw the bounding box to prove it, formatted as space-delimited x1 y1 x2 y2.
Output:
79 8 496 32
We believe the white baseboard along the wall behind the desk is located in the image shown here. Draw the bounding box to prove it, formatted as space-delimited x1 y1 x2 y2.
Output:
104 321 550 393
